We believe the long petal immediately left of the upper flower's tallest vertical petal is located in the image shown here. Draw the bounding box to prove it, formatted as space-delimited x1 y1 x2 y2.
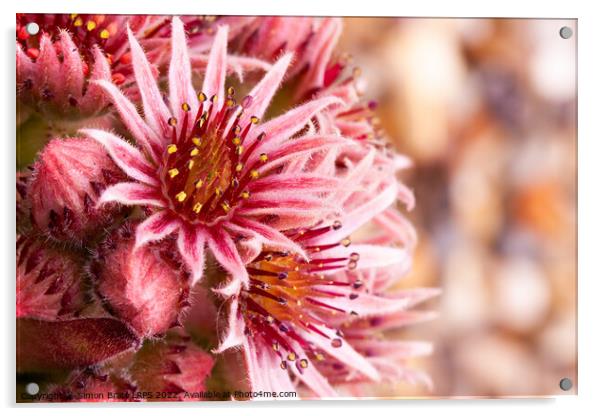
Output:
128 27 171 137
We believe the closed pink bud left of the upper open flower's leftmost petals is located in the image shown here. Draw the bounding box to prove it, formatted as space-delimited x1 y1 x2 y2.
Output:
27 138 123 243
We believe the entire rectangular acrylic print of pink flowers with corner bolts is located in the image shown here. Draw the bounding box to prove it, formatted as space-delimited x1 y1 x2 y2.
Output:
16 14 577 402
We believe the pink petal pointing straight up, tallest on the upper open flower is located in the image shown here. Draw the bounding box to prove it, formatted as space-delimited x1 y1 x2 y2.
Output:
169 17 198 127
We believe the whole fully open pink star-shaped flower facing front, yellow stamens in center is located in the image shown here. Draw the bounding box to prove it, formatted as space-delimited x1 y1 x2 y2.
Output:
83 18 343 293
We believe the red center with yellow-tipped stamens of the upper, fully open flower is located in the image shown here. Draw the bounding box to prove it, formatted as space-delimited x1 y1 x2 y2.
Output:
162 88 268 223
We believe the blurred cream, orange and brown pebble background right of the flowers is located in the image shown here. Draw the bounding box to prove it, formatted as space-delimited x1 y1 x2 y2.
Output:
339 18 577 396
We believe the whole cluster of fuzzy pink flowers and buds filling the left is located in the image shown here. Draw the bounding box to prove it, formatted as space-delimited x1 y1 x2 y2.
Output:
16 14 437 400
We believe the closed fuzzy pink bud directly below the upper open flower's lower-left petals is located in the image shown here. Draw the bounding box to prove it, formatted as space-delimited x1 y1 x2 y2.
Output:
90 225 189 337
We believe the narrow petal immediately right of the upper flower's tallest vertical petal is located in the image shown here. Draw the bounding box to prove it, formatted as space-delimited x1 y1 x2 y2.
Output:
202 26 228 108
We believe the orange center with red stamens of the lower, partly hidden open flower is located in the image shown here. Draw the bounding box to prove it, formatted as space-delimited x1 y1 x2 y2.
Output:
241 226 362 371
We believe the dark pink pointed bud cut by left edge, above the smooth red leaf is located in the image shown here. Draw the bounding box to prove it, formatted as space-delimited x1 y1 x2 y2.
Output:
17 236 85 320
